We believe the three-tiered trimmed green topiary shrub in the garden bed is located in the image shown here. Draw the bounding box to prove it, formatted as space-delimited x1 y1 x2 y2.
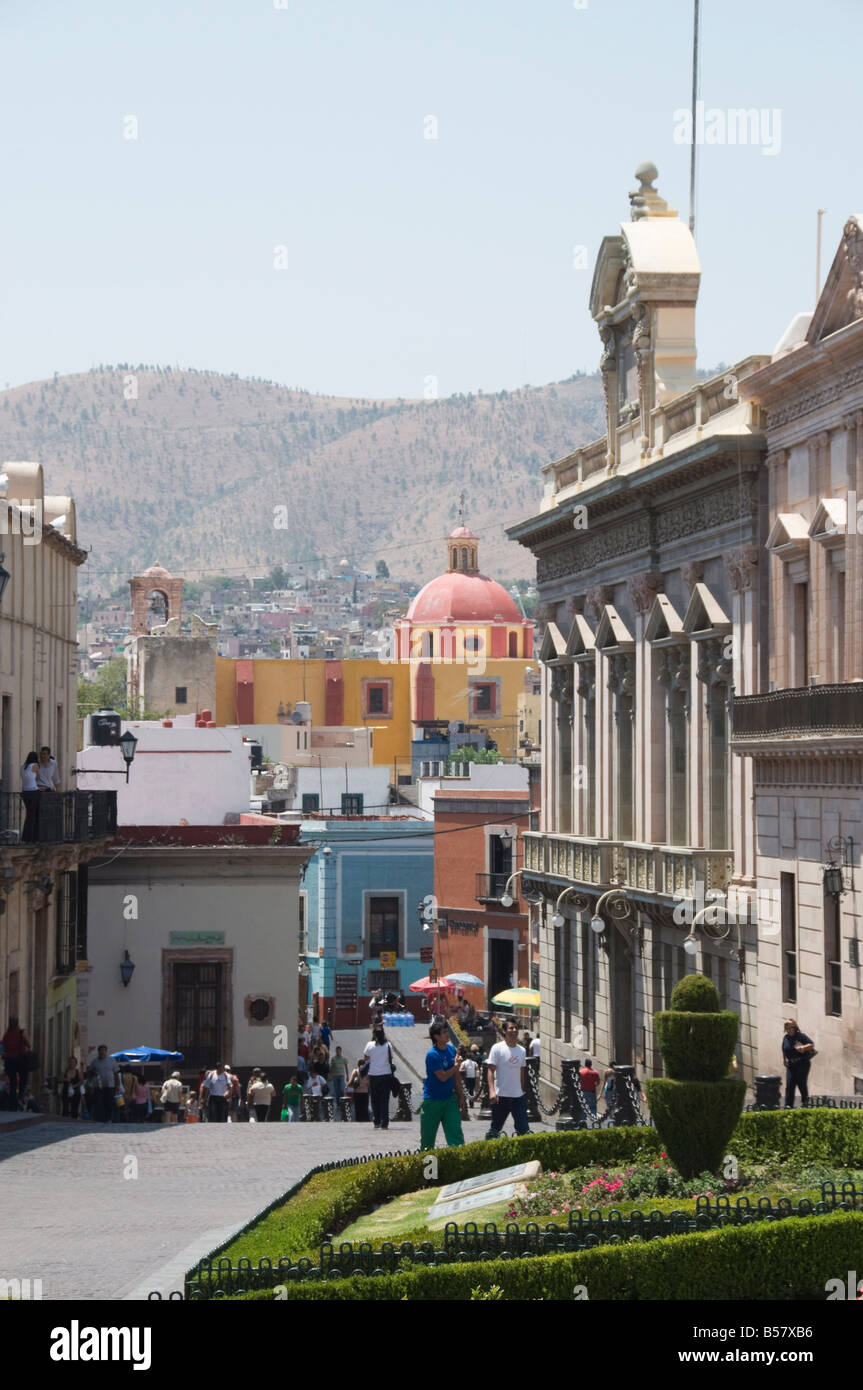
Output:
645 974 746 1177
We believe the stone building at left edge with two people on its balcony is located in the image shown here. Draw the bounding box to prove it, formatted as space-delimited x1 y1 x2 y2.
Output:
0 463 117 1093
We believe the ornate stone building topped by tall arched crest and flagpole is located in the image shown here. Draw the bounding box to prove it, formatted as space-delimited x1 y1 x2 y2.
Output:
509 165 767 1080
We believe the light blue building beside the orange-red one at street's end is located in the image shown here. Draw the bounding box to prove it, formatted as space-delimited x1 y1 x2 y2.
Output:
300 816 435 1031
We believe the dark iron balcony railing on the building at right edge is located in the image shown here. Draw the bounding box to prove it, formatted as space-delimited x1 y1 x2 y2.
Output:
731 682 863 738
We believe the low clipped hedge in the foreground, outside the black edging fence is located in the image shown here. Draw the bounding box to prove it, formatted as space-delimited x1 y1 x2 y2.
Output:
236 1212 863 1304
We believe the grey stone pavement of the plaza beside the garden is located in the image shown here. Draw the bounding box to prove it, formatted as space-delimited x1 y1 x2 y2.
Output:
0 1095 543 1300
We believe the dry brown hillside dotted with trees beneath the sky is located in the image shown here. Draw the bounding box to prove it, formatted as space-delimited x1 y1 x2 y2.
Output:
0 367 605 592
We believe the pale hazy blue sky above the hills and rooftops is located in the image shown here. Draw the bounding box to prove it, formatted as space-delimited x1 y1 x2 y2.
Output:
0 0 863 398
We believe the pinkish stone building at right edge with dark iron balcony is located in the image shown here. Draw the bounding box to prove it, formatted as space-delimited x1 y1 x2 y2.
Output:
732 217 863 1094
